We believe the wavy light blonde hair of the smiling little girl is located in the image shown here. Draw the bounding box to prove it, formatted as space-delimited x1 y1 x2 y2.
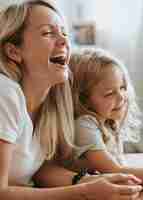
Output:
69 49 141 142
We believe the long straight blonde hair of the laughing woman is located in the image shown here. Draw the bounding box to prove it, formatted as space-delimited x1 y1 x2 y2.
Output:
0 0 74 159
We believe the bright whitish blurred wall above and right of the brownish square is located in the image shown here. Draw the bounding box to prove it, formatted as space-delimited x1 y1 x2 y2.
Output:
59 0 143 106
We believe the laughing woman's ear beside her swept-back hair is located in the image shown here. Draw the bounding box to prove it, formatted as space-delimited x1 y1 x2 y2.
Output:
4 42 22 63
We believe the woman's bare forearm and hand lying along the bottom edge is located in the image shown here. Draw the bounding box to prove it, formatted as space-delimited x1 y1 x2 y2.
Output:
0 175 142 200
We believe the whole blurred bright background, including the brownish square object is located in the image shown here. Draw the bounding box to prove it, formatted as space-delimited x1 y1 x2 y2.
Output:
0 0 143 108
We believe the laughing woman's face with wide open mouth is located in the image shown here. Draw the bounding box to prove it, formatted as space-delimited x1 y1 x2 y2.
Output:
19 5 70 85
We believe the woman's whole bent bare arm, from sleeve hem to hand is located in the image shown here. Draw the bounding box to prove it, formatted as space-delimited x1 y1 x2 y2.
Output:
0 141 142 200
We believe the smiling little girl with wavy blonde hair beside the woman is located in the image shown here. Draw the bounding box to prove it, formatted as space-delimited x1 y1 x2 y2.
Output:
70 50 143 180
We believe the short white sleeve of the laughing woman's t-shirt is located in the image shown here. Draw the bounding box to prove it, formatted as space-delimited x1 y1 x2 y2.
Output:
0 85 22 143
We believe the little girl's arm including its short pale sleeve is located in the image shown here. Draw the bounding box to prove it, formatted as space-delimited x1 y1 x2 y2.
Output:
76 117 143 180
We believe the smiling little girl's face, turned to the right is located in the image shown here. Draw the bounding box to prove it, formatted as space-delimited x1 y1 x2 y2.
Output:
89 65 127 121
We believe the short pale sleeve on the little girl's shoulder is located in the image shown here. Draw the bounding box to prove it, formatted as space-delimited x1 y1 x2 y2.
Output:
75 116 106 157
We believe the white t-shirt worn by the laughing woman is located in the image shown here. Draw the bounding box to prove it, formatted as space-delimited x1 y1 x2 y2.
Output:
0 74 46 185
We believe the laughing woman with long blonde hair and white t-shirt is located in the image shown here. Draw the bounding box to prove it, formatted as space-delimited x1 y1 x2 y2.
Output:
0 0 142 200
